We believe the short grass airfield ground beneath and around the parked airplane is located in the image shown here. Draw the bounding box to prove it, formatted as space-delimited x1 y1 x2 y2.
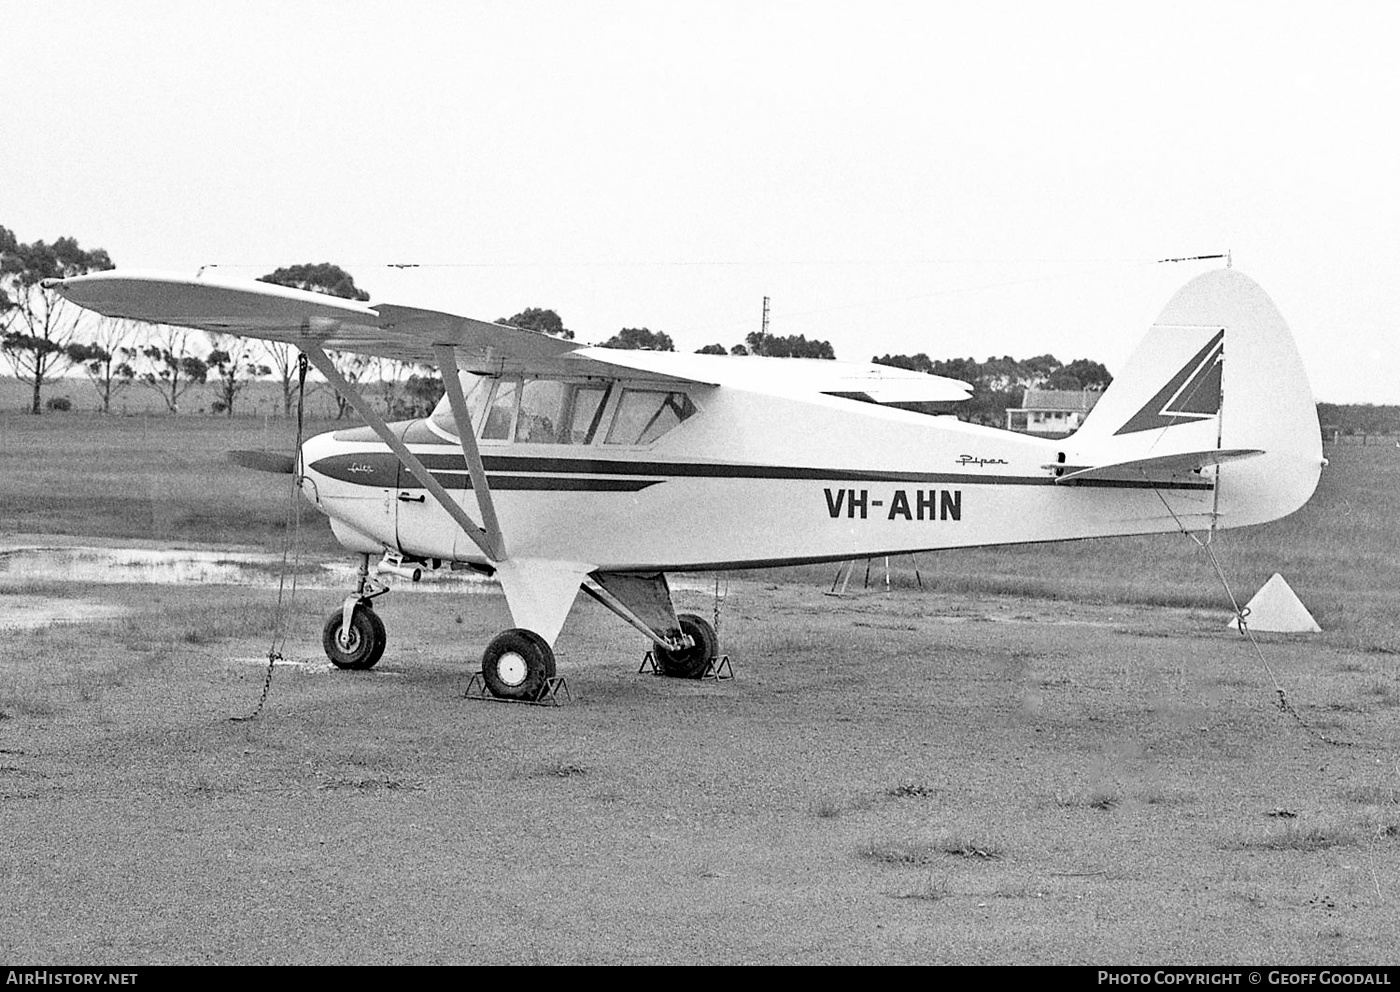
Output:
0 417 1400 964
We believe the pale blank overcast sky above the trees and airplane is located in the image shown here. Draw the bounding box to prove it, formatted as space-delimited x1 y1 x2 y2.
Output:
0 0 1400 403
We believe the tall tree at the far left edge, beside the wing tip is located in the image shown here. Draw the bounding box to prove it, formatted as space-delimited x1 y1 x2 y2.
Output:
0 227 112 414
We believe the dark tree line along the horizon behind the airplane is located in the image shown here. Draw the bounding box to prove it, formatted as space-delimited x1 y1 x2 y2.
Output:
0 227 1170 425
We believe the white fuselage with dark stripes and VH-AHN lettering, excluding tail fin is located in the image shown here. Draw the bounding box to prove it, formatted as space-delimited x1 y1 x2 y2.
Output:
304 385 1215 571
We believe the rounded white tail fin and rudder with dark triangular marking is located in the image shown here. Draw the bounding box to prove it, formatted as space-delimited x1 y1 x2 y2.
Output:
1060 269 1323 527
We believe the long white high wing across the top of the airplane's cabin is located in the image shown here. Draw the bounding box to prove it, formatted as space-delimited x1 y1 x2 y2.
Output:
45 270 972 403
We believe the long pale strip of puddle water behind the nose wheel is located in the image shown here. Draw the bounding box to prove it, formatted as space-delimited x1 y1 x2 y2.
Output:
0 547 500 593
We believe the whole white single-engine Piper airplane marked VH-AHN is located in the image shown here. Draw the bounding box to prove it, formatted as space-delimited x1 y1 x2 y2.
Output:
46 269 1323 700
